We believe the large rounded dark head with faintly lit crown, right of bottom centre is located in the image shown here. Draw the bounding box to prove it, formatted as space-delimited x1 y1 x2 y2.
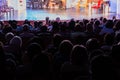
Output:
70 45 88 65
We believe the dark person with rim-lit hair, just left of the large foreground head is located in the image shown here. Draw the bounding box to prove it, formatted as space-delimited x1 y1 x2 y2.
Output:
53 40 73 77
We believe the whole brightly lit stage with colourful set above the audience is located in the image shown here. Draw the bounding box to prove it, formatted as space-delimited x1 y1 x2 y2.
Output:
0 0 120 20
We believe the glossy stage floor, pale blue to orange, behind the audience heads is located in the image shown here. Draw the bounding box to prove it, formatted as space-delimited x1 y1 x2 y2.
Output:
0 8 119 20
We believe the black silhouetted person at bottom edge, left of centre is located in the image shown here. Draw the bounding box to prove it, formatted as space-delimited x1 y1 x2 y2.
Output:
32 53 52 80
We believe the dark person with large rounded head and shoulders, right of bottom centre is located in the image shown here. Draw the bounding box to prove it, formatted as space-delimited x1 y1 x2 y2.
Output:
61 45 90 80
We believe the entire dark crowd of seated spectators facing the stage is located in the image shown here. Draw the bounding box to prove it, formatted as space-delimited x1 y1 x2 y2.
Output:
0 17 120 80
